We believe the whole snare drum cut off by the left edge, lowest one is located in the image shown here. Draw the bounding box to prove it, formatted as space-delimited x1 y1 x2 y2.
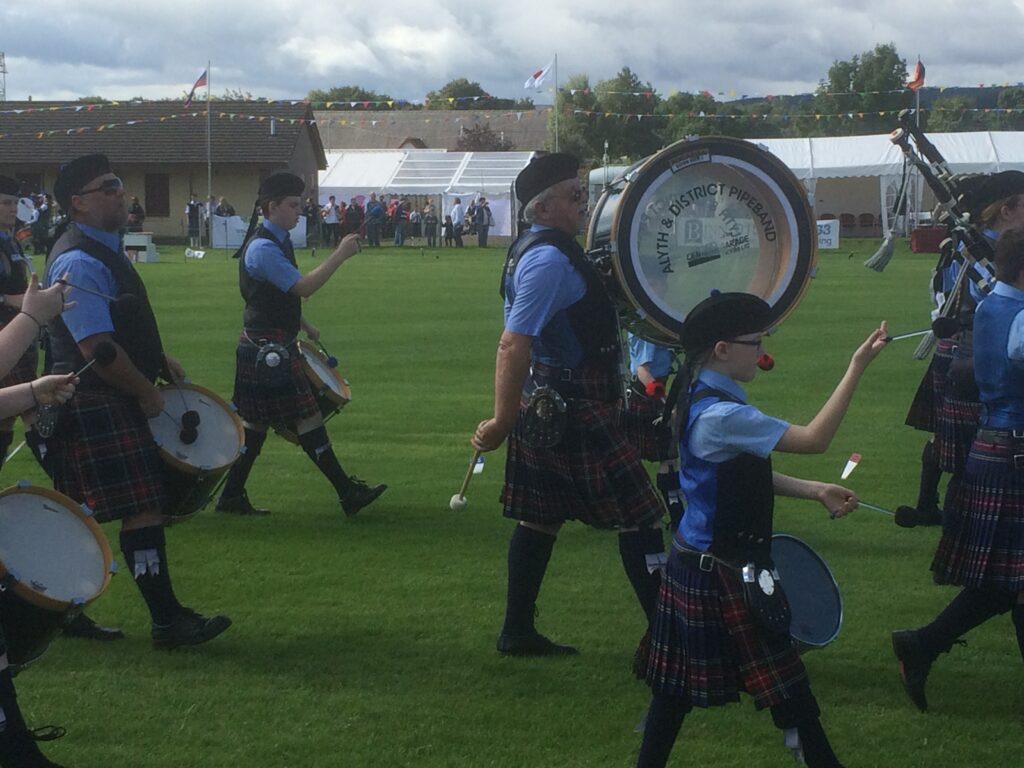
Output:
0 481 113 667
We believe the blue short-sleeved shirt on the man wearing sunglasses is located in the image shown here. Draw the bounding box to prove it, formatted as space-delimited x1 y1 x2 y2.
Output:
46 224 122 342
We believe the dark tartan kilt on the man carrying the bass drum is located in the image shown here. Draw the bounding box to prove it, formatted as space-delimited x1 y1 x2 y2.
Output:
501 366 664 528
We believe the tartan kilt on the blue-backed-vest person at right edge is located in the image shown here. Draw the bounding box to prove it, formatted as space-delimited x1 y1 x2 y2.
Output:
932 439 1024 592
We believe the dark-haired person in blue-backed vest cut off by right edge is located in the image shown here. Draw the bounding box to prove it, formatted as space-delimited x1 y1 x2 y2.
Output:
892 229 1024 712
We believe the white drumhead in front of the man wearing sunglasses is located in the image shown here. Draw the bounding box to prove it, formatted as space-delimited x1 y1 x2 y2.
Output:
150 384 243 471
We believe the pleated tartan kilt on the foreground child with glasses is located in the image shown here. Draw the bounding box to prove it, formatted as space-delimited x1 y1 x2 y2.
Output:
646 551 809 710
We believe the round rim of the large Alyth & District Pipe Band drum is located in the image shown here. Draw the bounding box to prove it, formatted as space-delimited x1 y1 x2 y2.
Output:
588 136 817 346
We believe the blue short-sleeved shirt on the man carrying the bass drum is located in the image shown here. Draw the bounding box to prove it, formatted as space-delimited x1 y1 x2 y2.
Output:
505 224 587 368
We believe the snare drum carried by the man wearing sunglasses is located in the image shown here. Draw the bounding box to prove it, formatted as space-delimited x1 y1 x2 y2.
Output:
150 384 245 522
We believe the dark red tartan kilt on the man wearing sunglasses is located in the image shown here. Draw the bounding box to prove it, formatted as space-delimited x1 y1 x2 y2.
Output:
47 388 166 522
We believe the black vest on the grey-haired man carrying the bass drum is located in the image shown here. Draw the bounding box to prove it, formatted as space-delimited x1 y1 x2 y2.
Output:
500 229 622 376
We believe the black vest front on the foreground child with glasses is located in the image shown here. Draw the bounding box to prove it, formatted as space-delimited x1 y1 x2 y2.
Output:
690 389 775 564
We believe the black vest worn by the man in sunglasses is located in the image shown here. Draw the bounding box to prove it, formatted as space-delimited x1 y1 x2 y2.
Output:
46 224 165 389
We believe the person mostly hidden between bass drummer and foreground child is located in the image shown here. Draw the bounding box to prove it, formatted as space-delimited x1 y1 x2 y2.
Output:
623 334 683 530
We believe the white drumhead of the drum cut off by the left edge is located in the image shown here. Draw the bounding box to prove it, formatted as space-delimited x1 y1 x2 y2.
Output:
0 489 109 604
